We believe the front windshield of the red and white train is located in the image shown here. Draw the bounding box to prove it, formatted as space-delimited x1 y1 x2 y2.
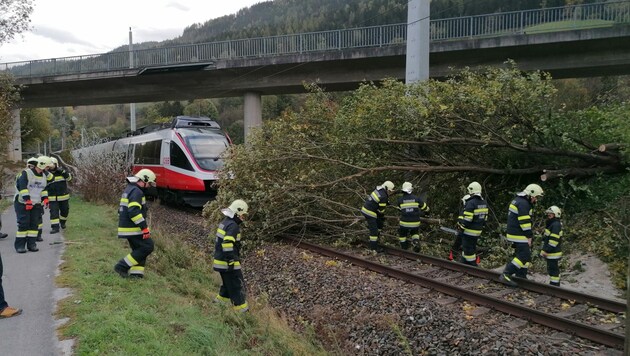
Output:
179 128 228 171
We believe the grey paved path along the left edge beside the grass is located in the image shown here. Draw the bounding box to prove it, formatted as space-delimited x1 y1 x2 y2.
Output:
0 203 72 356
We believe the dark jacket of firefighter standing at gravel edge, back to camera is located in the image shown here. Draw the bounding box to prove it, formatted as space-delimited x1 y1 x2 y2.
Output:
212 215 242 272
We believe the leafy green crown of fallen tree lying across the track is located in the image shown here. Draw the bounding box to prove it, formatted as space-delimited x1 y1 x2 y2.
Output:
206 64 630 286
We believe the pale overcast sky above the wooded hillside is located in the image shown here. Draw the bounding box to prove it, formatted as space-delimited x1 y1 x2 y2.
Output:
0 0 265 63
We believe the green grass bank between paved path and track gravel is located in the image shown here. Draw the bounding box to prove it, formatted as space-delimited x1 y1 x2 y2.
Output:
57 197 325 355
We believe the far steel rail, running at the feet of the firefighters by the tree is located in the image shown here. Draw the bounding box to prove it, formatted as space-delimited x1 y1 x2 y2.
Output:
383 246 626 313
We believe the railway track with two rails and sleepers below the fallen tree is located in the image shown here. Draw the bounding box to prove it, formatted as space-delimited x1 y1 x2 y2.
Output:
288 239 625 349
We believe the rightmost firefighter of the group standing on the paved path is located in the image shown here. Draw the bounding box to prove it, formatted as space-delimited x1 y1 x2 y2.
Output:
48 157 72 234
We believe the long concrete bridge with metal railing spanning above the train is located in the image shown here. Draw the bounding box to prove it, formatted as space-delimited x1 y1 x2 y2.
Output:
0 1 630 160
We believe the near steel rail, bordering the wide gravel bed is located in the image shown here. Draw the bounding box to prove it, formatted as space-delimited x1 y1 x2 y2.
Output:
286 237 625 349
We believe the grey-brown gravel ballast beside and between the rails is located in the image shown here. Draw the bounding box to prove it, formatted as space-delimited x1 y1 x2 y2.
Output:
152 205 621 355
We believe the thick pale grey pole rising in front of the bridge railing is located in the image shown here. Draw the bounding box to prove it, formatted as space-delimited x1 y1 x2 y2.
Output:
405 0 431 84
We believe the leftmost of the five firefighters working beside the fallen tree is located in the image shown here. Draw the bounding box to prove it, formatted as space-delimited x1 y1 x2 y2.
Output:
361 181 394 251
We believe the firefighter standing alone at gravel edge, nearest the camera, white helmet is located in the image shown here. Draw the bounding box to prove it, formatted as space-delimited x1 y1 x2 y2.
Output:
213 199 249 312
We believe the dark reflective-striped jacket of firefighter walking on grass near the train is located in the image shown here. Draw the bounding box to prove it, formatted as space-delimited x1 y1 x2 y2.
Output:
118 182 147 239
